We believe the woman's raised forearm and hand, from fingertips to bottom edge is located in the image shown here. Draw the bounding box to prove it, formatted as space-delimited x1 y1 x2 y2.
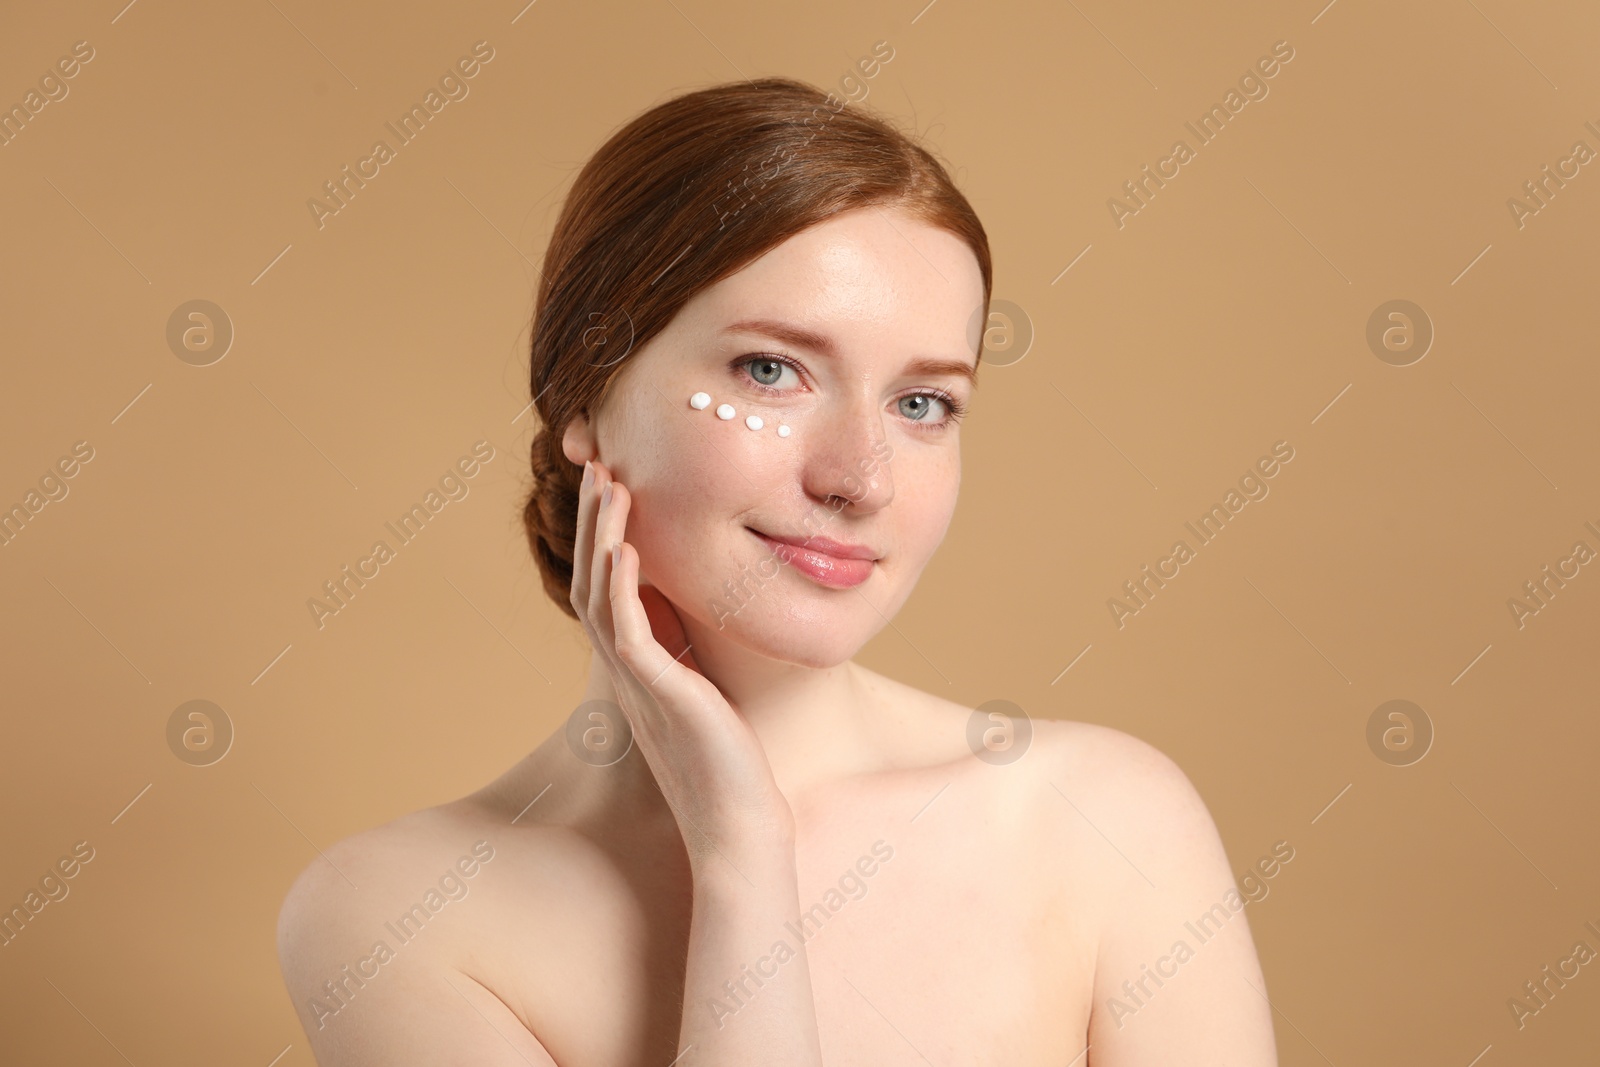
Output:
571 461 822 1067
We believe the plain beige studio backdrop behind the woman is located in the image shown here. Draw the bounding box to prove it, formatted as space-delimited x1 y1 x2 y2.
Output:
0 0 1600 1067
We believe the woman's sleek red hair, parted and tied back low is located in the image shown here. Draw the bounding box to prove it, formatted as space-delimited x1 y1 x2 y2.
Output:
522 78 994 617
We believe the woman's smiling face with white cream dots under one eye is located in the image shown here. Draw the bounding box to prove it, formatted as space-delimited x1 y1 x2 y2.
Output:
563 208 984 667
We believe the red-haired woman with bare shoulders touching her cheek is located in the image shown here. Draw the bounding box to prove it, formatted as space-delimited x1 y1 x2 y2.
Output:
278 78 1275 1067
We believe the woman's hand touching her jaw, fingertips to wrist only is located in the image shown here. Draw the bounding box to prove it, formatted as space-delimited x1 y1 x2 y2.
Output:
571 461 794 869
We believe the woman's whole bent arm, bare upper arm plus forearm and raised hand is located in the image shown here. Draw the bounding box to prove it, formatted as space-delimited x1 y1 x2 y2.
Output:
278 464 822 1067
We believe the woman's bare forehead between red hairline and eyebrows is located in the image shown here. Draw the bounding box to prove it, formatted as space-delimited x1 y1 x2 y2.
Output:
683 206 984 357
